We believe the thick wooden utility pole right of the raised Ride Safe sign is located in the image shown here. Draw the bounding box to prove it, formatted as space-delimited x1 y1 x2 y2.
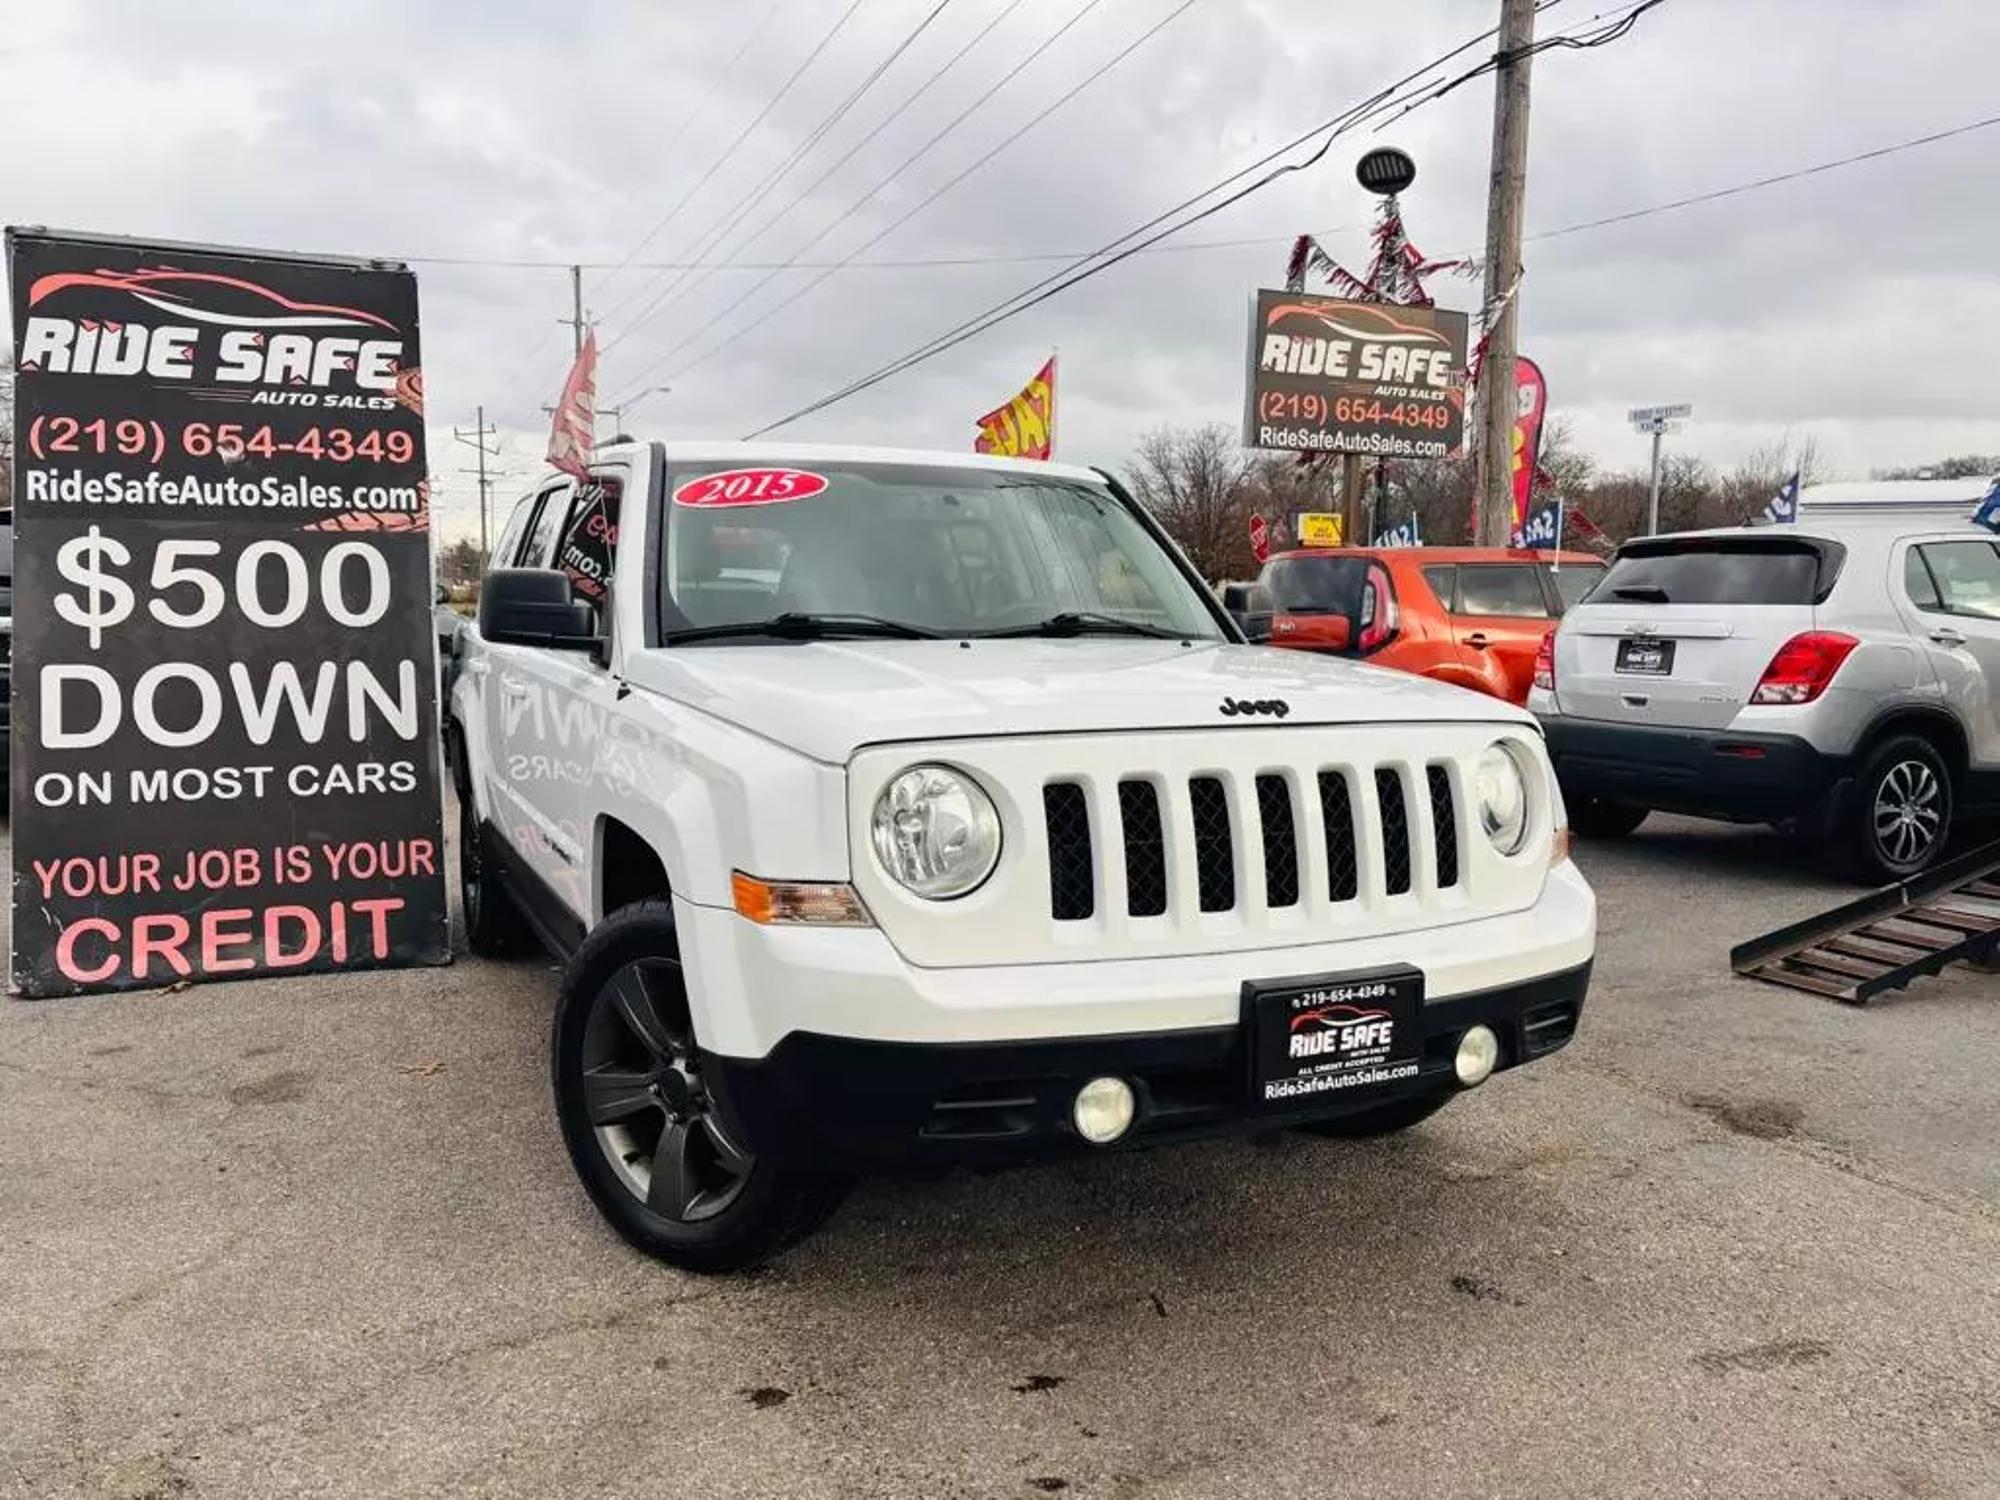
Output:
1472 0 1534 546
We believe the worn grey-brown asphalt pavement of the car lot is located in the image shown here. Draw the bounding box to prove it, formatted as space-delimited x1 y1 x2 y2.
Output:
0 818 2000 1500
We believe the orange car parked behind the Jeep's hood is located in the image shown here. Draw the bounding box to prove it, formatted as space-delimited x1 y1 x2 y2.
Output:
1242 546 1604 704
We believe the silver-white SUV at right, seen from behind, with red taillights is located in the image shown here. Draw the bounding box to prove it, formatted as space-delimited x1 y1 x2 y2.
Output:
1528 518 2000 880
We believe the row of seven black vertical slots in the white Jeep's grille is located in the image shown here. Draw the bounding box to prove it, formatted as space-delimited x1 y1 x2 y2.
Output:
1042 764 1458 922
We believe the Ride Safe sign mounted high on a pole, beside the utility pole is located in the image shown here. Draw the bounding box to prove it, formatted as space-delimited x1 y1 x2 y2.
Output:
1244 292 1466 458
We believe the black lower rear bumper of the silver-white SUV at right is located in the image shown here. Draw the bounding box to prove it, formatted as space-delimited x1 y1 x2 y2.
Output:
1538 714 1850 822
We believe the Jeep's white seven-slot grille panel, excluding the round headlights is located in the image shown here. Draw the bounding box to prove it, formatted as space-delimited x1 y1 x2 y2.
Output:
848 722 1550 976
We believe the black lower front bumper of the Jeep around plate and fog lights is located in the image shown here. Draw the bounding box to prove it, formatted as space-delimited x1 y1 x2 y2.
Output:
702 964 1590 1168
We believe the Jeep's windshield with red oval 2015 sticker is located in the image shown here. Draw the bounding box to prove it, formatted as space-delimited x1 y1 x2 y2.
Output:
662 462 1222 640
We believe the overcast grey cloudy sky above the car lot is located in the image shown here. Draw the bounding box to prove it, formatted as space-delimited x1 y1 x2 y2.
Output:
0 0 2000 530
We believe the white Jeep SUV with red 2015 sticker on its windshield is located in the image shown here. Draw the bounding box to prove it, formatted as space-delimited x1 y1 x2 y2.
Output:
448 444 1596 1270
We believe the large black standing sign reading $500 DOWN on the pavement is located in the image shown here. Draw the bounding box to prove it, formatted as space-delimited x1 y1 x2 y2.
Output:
8 230 448 996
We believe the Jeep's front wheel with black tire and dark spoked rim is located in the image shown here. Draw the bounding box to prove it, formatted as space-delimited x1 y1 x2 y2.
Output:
550 900 848 1272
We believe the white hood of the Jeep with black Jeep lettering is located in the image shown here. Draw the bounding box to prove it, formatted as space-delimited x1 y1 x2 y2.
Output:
628 636 1532 764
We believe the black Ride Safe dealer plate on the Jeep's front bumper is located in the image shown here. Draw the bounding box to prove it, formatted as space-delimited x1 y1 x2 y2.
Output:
1244 966 1424 1108
